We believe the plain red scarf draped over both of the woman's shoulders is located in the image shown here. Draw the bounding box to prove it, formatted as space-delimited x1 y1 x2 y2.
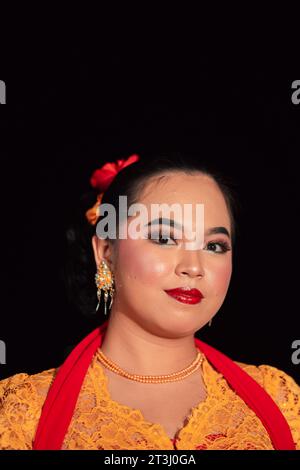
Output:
33 321 295 450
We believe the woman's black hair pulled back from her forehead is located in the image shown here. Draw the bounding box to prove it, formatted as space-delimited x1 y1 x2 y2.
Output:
63 153 239 321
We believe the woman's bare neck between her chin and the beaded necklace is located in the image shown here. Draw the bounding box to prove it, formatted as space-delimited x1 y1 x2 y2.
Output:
101 310 198 375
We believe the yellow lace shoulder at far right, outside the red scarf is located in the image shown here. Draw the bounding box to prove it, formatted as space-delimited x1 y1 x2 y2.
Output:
235 361 300 450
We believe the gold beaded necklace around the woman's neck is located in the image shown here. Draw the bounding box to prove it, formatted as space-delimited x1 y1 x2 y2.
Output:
97 349 203 384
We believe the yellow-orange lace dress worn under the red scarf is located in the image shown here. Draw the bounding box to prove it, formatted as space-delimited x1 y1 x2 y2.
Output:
0 355 300 450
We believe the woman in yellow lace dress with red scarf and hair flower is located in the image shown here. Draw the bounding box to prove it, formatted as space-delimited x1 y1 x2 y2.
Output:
0 155 300 450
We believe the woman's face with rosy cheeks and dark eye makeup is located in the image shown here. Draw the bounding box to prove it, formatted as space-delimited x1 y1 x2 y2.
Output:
94 172 232 338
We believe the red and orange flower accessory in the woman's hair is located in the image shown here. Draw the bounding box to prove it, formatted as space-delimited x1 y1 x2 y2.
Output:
85 154 140 225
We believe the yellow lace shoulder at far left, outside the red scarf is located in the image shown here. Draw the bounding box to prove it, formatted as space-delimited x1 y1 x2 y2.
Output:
0 369 57 450
